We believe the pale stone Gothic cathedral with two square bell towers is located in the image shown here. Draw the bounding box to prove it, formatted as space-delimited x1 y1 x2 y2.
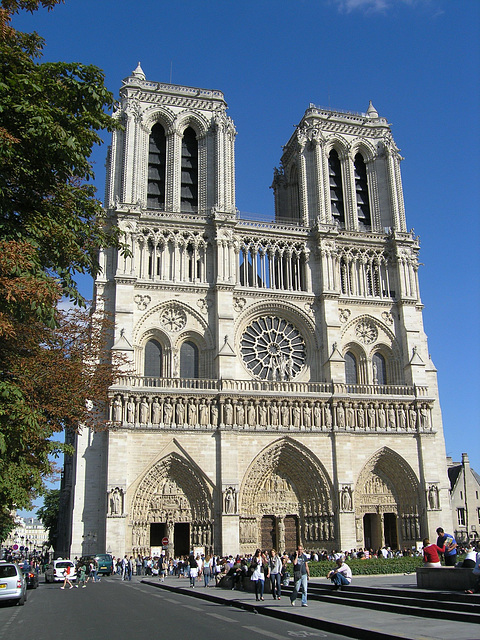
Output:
70 65 452 557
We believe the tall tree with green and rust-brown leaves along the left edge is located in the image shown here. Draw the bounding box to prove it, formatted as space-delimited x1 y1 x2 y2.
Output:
0 0 125 538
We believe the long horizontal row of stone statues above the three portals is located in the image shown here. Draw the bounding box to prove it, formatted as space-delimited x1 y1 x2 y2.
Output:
111 395 431 431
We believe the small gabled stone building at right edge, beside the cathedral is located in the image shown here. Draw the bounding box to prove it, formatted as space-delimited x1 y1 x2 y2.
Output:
447 453 480 543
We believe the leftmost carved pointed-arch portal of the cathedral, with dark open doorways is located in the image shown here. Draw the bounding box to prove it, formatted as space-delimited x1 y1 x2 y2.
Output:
130 452 213 555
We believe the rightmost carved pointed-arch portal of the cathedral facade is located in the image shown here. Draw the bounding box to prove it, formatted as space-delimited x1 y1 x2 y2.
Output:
355 447 422 549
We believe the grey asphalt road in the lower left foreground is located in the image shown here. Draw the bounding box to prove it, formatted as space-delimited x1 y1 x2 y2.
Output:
0 576 345 640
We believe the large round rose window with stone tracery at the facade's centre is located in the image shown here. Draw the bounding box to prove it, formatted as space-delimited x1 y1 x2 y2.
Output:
241 316 305 380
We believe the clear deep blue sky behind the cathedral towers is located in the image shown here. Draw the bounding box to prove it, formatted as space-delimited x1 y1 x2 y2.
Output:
14 0 480 492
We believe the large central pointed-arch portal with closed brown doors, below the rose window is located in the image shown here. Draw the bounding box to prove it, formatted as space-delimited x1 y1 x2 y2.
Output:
240 438 336 552
